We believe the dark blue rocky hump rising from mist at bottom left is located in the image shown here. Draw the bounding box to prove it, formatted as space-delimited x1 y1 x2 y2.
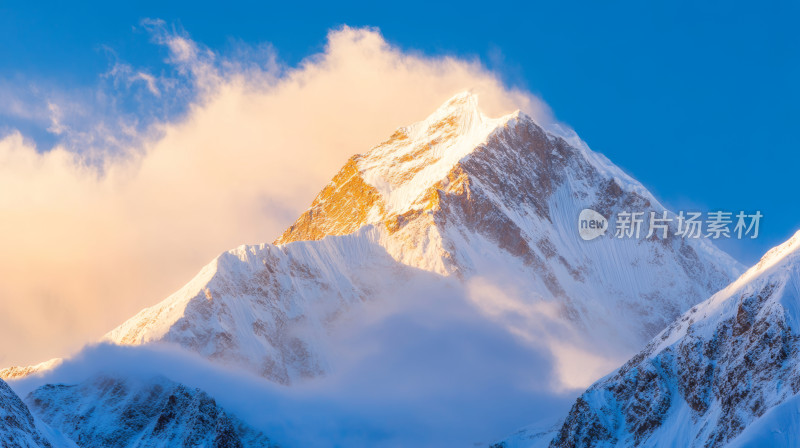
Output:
27 377 274 448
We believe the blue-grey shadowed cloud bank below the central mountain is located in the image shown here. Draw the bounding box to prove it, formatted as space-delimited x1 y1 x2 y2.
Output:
12 278 579 447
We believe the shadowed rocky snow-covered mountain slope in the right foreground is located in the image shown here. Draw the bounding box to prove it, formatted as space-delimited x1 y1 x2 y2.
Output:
551 232 800 447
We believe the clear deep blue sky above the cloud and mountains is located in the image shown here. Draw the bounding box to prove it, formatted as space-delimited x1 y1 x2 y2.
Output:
0 1 800 264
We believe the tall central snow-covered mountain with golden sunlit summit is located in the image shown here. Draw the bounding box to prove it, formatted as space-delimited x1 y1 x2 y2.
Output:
101 93 740 387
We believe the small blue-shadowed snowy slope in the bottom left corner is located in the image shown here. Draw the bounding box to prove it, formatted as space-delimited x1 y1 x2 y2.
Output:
0 380 53 448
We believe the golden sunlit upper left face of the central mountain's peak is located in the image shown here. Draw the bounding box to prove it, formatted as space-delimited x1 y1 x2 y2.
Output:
275 92 519 244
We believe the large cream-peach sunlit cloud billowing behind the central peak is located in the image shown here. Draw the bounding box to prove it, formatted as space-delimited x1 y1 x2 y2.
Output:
0 21 549 365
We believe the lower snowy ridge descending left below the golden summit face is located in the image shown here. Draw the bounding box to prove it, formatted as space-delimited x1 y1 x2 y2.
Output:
106 228 406 384
